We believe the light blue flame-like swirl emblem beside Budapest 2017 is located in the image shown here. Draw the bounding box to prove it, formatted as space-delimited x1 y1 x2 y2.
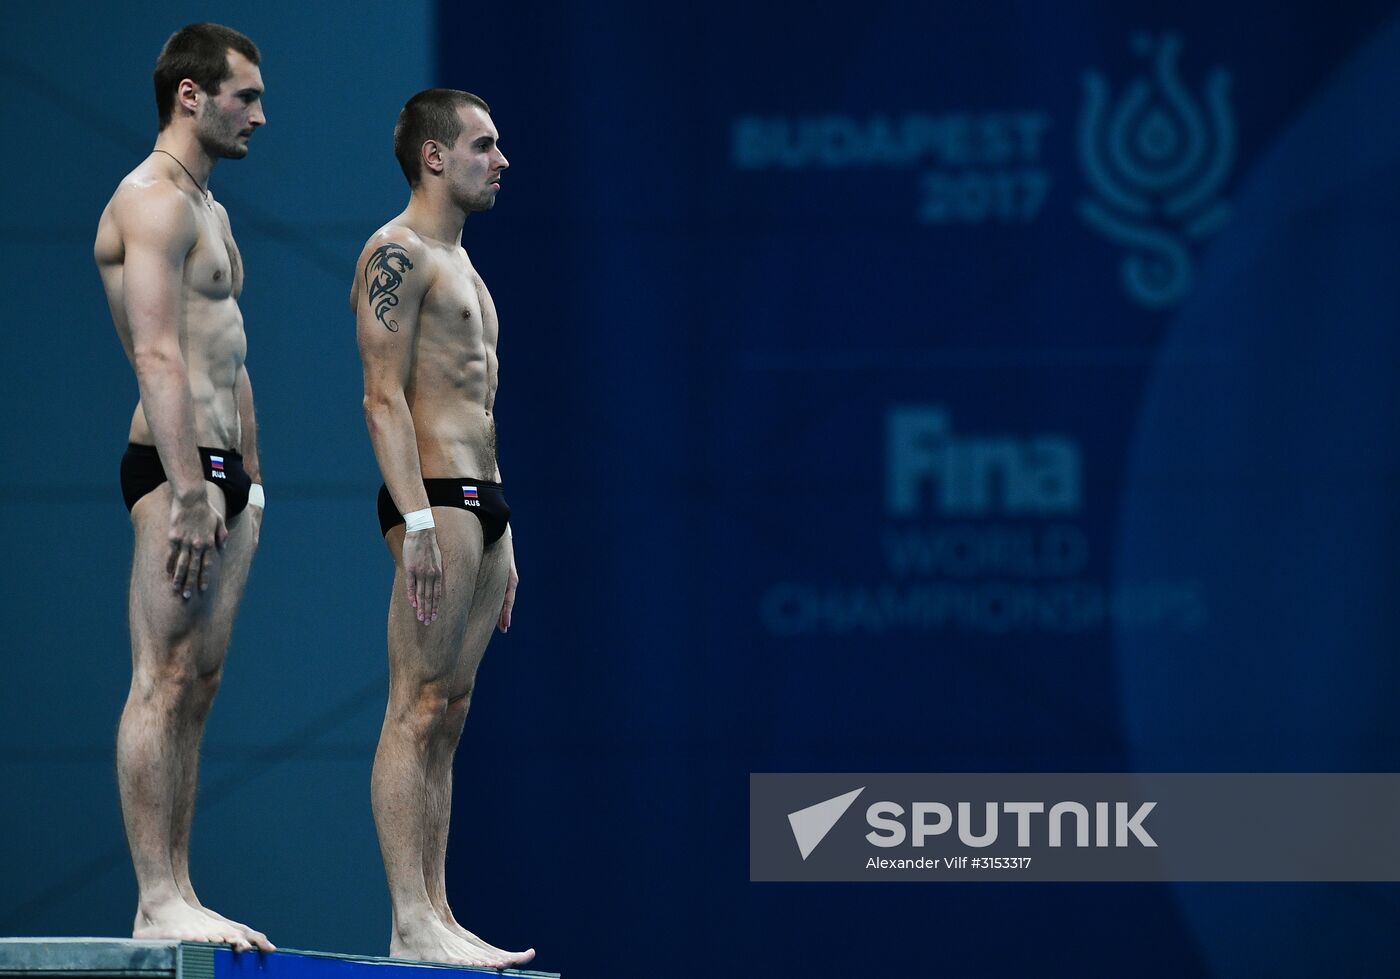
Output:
1079 34 1235 310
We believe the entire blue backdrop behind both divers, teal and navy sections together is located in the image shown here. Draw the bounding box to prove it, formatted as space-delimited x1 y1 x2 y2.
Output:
0 0 1400 979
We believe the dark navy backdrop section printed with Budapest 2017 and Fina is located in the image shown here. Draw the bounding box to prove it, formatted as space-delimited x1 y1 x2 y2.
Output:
437 3 1400 976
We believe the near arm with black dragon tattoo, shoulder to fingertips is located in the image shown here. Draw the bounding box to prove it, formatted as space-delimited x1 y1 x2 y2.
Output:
351 227 444 622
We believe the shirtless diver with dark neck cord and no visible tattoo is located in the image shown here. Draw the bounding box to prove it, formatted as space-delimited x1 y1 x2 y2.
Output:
94 24 273 951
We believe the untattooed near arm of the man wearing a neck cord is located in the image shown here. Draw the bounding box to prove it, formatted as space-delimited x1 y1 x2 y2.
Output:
118 185 228 598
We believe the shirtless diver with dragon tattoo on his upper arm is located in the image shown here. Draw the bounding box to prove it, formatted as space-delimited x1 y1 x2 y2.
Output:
350 88 535 968
